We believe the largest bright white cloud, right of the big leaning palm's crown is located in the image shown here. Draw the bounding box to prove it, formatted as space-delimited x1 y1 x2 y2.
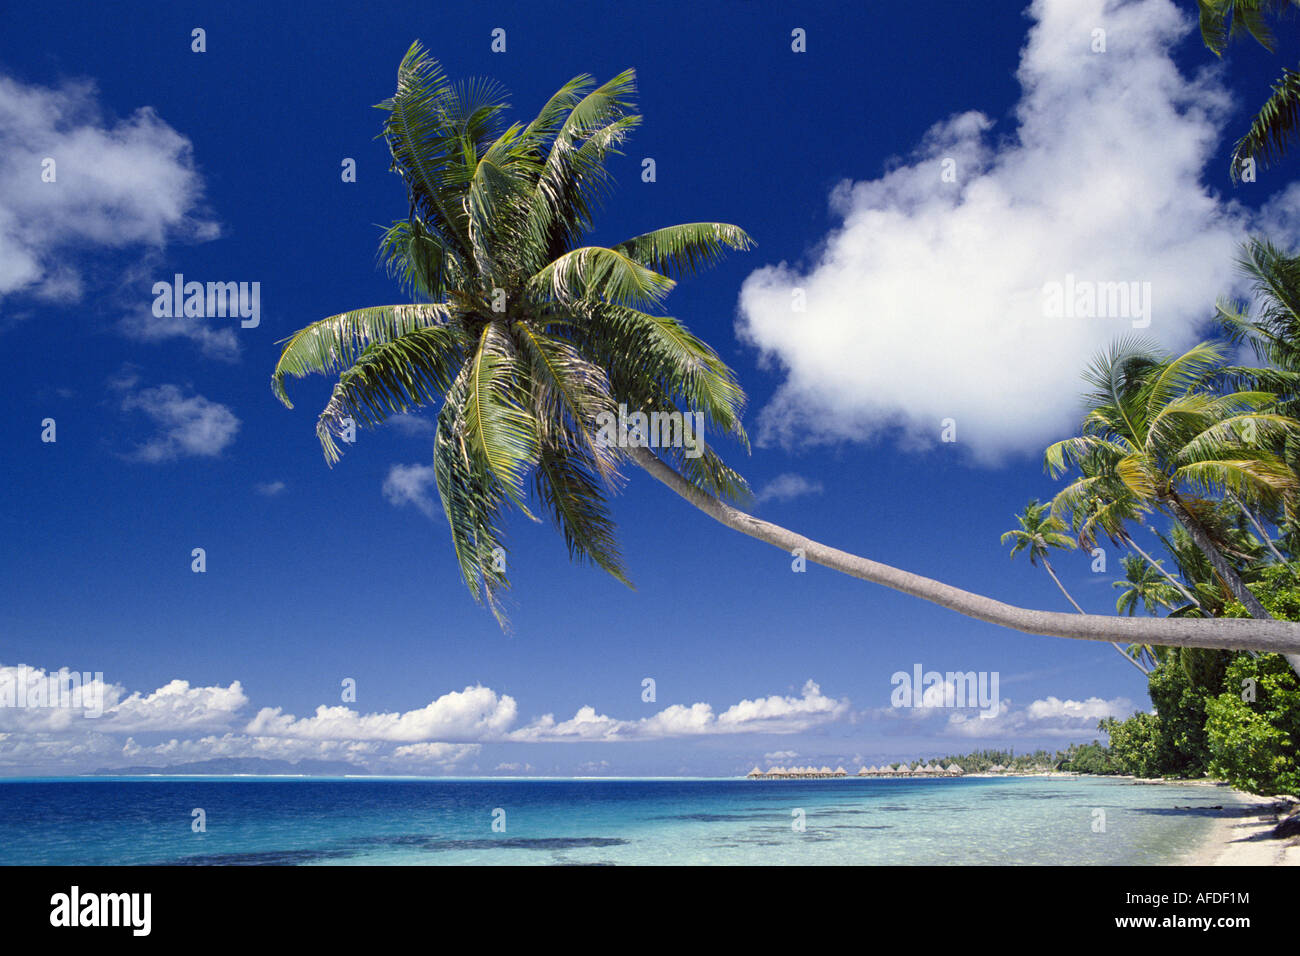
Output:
737 0 1295 460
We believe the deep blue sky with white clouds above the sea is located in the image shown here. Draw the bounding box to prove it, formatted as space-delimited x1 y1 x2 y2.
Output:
0 0 1296 775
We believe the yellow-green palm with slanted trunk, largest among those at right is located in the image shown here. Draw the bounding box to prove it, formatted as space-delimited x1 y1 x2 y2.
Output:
1044 339 1300 674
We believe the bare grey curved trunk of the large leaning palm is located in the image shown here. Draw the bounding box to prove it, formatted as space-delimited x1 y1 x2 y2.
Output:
628 447 1300 661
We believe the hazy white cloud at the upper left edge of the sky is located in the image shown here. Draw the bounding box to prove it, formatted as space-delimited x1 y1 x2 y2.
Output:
0 75 218 308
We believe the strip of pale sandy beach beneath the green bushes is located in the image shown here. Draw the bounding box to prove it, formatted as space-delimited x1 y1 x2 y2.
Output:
1121 778 1300 866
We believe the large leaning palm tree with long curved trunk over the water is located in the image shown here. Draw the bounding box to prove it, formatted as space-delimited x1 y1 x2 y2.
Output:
272 44 1300 650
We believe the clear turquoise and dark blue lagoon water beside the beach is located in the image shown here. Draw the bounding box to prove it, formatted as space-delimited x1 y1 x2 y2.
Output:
0 778 1236 865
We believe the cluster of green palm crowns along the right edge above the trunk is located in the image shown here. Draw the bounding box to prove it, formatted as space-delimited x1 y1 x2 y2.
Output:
1002 239 1300 674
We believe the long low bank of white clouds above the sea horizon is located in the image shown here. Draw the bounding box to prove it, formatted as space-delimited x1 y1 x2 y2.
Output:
0 666 849 773
